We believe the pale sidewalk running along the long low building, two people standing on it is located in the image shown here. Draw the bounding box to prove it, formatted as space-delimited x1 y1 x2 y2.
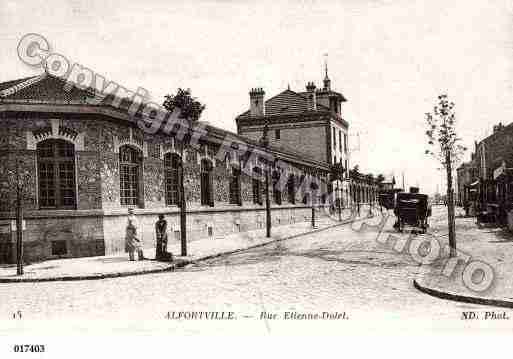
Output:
0 211 370 283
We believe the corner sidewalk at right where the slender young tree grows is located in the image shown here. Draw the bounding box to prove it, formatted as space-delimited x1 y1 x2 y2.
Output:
416 211 513 307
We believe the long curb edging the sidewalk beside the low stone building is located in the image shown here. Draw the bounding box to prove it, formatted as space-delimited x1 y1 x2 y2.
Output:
0 217 369 284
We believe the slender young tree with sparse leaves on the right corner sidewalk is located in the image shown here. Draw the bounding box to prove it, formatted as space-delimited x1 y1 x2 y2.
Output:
426 94 466 257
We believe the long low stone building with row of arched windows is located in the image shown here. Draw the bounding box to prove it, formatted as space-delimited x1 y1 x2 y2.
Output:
0 69 375 263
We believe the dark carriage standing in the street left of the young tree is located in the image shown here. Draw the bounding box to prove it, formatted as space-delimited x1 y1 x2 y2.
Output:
394 192 431 233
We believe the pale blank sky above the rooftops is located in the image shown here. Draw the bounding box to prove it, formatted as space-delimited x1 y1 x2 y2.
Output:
0 0 513 194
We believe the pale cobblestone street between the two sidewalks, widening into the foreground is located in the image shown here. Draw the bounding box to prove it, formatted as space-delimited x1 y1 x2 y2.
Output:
0 210 504 334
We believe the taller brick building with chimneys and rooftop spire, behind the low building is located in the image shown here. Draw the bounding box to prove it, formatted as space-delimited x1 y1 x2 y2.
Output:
235 69 360 206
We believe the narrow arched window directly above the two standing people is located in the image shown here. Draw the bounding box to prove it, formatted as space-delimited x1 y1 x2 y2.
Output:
119 145 142 206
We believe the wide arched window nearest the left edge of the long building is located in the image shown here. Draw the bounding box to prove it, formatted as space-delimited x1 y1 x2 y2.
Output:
37 139 76 209
